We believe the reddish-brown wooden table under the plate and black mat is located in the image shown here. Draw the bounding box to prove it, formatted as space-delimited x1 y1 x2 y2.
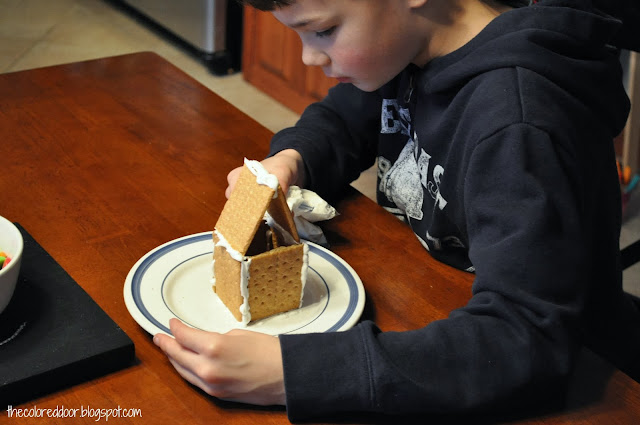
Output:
0 53 640 425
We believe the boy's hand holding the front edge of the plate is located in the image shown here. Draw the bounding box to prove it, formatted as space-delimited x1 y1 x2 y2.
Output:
153 319 285 406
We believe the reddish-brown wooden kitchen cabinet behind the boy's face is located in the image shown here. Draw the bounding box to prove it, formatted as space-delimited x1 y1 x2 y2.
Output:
242 7 338 113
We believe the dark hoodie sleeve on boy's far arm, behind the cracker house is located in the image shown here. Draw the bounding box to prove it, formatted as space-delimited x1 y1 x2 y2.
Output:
269 84 382 199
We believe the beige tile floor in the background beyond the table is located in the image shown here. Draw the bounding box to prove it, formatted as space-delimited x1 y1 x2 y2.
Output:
0 0 640 296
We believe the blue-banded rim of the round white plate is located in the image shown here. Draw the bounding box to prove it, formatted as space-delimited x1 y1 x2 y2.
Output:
124 232 364 335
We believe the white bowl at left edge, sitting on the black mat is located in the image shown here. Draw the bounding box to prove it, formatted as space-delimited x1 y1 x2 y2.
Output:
0 216 24 313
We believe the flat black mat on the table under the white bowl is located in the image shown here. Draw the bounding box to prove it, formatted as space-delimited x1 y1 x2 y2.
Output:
0 224 135 409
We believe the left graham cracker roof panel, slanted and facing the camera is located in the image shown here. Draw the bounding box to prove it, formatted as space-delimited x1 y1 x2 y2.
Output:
216 165 274 255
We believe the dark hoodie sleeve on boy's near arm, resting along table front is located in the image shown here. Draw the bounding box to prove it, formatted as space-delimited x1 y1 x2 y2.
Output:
280 124 589 421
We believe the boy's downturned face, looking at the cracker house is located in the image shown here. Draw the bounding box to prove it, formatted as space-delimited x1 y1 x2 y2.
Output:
273 0 425 91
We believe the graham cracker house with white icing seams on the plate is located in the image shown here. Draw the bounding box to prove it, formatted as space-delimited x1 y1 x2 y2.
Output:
212 159 308 324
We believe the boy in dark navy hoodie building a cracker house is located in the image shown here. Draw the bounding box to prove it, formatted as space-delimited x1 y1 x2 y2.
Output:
155 0 640 420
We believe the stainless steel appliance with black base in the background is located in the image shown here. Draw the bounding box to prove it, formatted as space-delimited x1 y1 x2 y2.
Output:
115 0 242 74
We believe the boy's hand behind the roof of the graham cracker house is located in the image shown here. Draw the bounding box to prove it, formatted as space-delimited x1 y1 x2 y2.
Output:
225 149 304 198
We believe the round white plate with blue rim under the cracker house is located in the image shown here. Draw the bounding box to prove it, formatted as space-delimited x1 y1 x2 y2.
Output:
124 232 365 335
